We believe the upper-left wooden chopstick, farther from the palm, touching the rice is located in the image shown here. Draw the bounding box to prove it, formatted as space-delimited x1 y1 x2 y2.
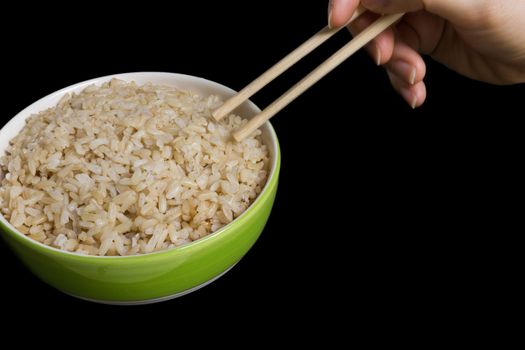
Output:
213 6 366 120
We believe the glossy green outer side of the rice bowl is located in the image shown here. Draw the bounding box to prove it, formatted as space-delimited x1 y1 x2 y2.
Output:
0 150 280 302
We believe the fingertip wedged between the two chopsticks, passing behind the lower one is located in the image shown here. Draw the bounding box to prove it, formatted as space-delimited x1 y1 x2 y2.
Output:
348 12 394 66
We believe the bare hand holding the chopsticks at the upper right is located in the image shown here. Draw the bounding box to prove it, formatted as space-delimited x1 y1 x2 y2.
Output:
328 0 525 108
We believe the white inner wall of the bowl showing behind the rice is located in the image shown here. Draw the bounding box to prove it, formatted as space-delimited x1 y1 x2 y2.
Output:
0 72 278 253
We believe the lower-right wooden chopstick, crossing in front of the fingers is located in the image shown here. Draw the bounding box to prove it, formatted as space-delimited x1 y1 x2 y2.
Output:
233 13 404 142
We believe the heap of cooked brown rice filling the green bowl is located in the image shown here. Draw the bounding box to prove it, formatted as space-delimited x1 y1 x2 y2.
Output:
0 80 269 255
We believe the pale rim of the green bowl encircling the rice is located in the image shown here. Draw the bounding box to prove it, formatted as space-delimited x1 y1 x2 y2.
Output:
0 71 281 261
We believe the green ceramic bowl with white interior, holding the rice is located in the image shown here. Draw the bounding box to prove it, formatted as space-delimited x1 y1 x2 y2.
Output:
0 72 280 304
